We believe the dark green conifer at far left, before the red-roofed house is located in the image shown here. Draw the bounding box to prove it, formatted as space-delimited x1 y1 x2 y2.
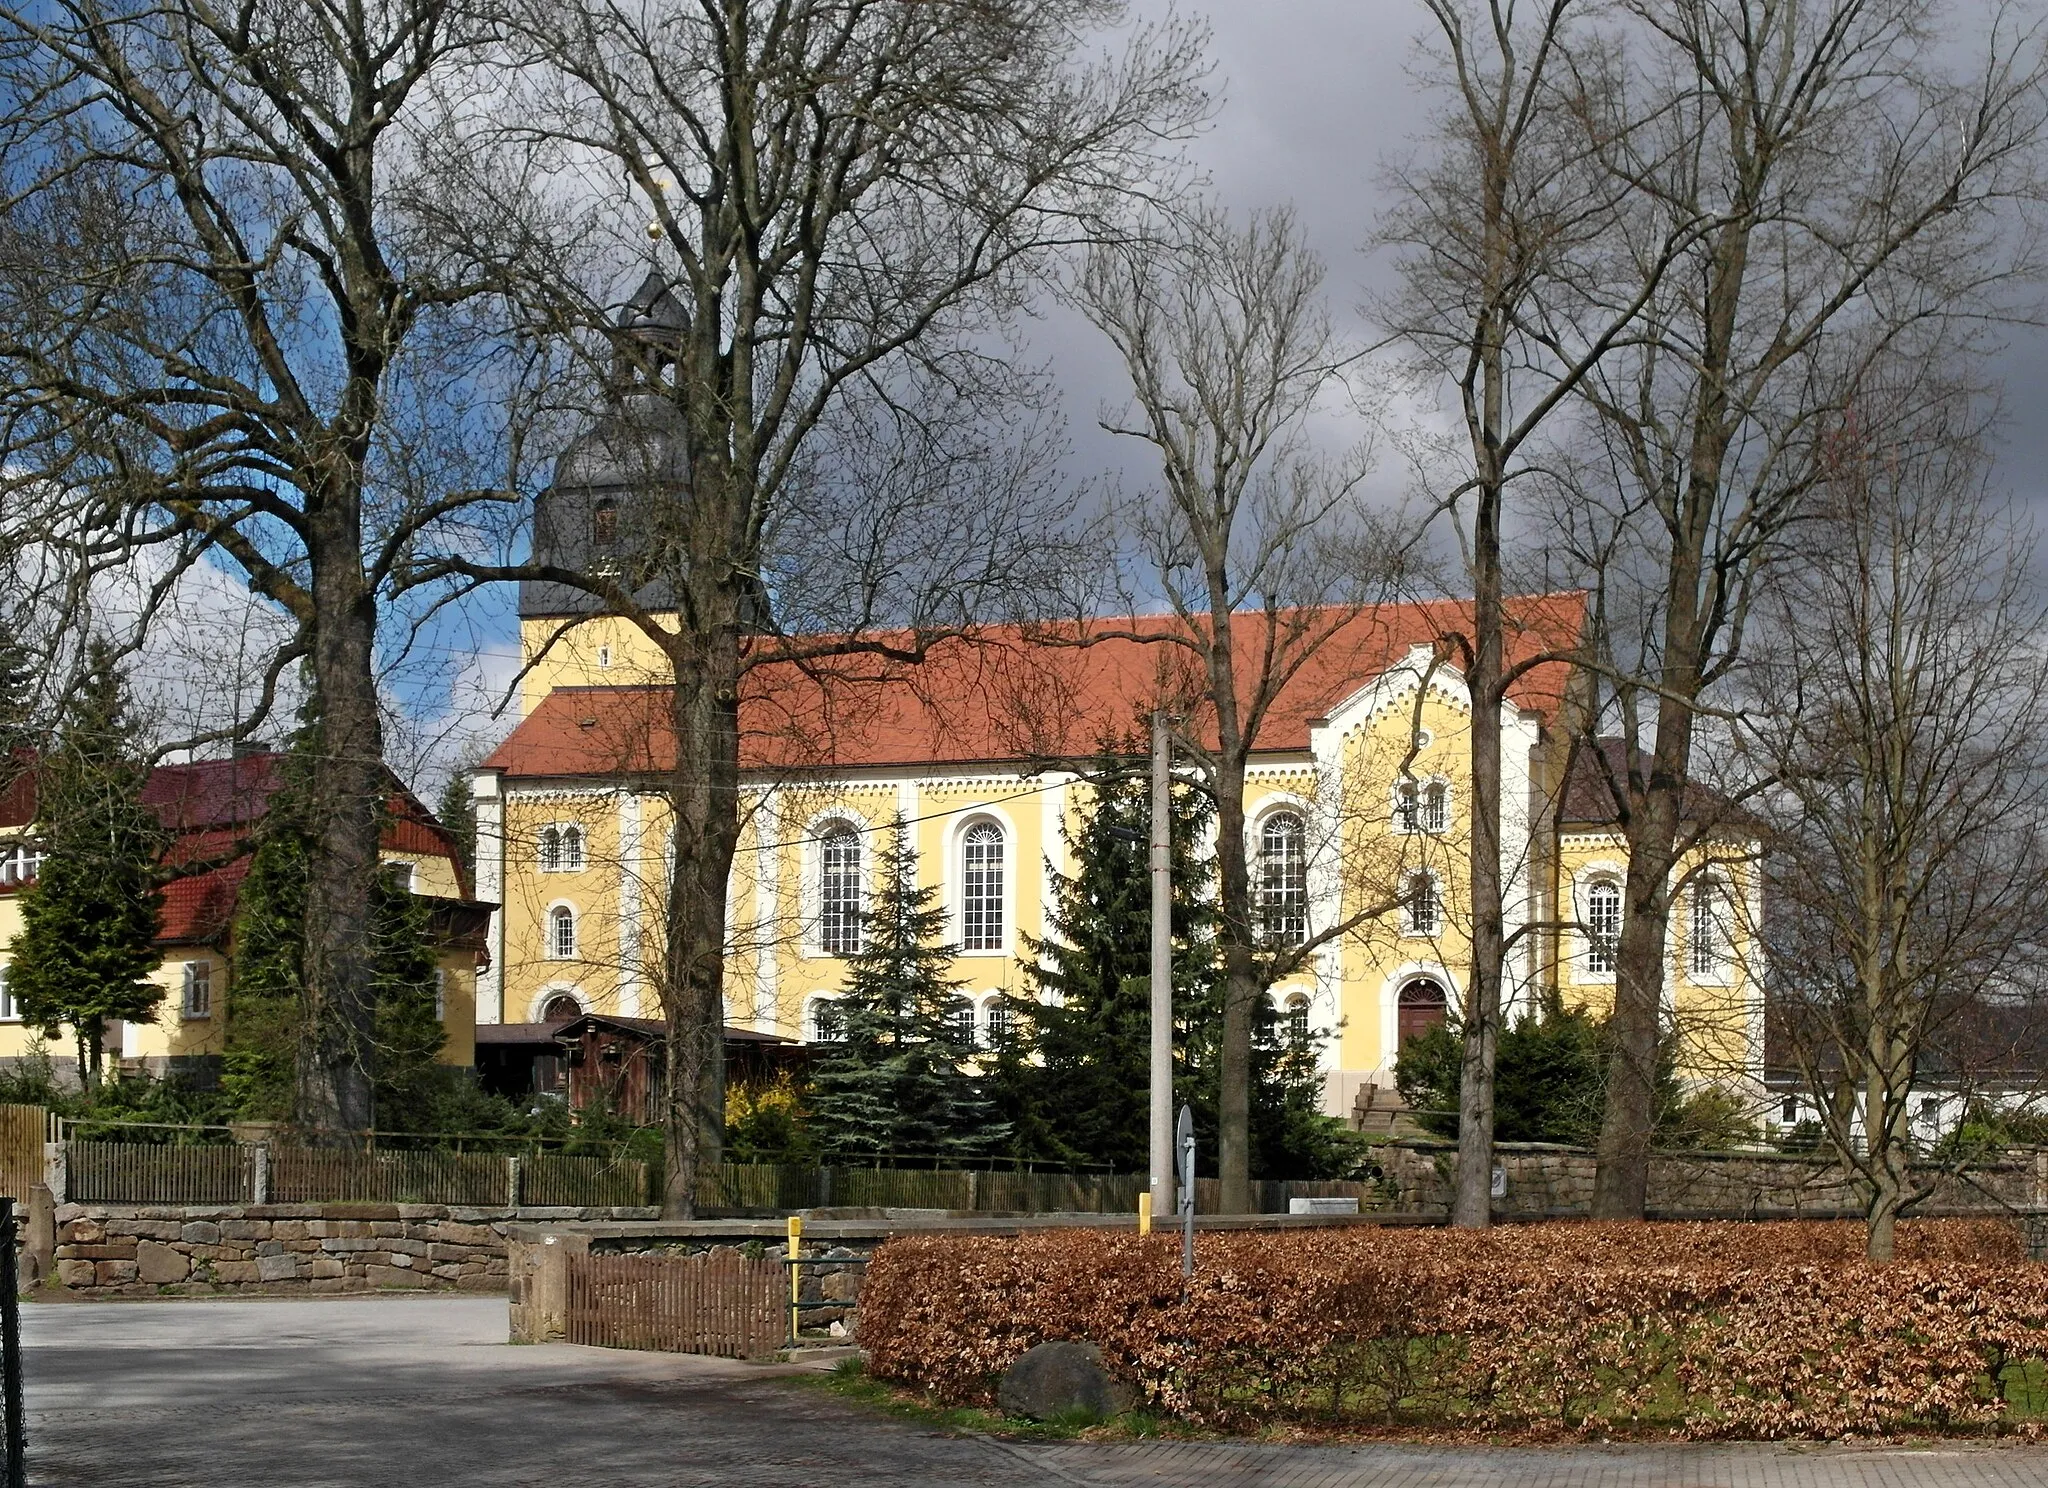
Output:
8 641 166 1089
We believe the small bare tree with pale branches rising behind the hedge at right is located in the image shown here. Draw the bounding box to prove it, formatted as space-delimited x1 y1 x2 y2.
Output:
1743 384 2048 1261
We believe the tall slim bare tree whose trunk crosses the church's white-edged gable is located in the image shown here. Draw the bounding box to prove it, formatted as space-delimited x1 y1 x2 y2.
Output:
1380 0 1698 1228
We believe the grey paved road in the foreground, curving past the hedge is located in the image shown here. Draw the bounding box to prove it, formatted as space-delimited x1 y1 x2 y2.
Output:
23 1298 2048 1488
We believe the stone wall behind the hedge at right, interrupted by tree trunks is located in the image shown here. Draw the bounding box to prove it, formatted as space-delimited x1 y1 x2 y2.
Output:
1378 1142 2048 1220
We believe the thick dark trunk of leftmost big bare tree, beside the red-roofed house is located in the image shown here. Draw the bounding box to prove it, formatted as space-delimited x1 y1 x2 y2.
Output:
297 497 385 1134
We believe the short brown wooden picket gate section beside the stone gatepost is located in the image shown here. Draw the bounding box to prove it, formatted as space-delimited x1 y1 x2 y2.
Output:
565 1249 788 1359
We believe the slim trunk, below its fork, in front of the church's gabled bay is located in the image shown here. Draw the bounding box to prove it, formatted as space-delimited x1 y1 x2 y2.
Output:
1450 483 1507 1230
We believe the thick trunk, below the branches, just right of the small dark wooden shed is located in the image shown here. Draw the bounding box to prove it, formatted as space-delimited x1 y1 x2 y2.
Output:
659 604 739 1220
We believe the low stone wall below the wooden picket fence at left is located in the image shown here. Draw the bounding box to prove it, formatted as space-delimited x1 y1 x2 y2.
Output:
43 1203 651 1298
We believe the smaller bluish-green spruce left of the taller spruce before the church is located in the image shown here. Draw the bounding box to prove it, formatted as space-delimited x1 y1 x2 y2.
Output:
811 819 1006 1158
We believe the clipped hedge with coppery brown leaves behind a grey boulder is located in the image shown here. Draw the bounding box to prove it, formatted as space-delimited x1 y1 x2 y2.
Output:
860 1220 2048 1437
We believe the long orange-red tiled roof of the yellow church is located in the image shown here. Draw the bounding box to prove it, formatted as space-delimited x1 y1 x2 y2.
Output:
483 592 1585 778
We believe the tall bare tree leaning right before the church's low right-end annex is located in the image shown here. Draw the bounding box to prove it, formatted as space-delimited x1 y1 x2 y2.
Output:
1554 0 2044 1218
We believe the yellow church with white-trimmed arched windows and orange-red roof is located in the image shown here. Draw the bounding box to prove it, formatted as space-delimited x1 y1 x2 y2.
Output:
473 596 1763 1115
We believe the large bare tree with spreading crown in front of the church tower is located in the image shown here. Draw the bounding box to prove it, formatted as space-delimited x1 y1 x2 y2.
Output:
421 0 1208 1216
